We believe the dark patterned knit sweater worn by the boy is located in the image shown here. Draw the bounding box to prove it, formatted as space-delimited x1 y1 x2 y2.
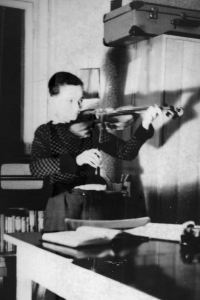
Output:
30 122 153 190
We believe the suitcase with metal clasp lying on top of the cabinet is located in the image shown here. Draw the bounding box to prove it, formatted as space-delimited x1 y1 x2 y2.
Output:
103 1 200 47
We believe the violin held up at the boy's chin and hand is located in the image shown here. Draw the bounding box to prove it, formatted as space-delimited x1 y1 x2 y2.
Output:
80 106 183 130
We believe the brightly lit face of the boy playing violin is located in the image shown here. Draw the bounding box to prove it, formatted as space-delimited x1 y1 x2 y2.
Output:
51 85 83 123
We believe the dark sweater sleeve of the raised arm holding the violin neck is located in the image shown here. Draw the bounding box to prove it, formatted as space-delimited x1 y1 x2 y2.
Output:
98 126 154 161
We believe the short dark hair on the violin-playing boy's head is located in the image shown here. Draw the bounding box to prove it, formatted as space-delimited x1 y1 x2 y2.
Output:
48 72 83 96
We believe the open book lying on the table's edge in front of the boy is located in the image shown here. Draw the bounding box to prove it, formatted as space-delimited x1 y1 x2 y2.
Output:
42 226 149 259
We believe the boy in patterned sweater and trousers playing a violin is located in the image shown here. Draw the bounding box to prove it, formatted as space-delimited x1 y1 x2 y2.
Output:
30 72 161 231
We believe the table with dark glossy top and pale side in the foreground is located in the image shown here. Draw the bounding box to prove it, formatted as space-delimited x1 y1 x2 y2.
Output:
5 233 200 300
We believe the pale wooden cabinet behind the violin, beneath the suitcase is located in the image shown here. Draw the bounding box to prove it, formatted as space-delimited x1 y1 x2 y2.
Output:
120 35 200 223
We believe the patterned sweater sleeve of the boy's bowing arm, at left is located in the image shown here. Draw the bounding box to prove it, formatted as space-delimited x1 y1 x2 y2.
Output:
30 125 78 178
